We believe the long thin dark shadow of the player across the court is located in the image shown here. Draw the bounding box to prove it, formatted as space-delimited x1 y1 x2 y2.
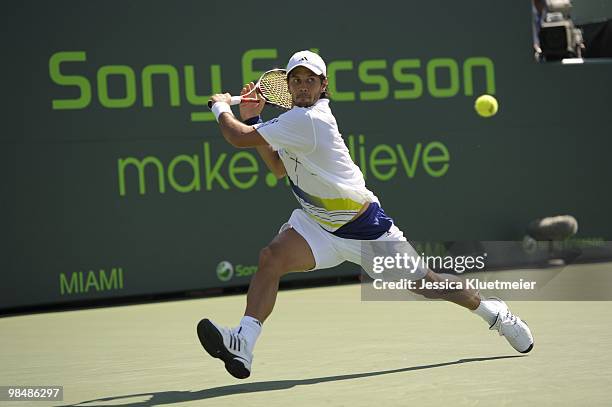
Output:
58 355 527 407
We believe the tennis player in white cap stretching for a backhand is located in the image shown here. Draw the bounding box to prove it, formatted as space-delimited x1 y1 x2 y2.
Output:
197 51 533 379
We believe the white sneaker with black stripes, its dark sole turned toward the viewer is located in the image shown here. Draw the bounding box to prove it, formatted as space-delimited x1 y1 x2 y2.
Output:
198 319 253 379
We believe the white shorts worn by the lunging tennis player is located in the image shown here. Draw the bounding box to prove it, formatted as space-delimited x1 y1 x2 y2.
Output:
278 209 427 279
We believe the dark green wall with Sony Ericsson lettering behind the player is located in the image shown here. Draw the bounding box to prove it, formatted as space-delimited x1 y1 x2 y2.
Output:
0 0 612 309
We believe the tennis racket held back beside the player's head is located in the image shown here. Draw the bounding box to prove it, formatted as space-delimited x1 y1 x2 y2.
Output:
208 69 293 110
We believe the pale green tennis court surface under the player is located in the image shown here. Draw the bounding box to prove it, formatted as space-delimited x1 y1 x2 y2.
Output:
0 265 612 407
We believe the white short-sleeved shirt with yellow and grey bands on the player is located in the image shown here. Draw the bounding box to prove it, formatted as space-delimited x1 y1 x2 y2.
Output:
254 99 378 232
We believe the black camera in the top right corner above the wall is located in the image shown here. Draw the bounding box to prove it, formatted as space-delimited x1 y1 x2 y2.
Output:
539 0 584 61
